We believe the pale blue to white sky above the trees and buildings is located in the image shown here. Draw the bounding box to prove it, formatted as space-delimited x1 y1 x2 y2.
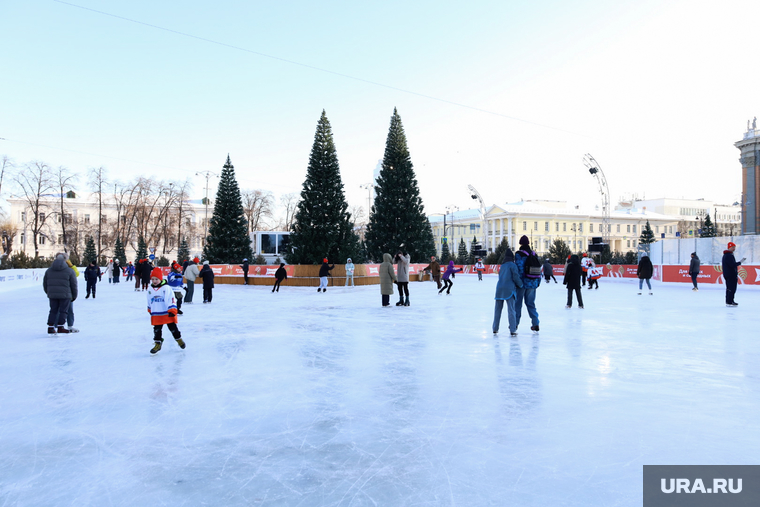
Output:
0 0 760 213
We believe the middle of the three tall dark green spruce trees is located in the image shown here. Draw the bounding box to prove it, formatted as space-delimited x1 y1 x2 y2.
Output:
285 110 361 264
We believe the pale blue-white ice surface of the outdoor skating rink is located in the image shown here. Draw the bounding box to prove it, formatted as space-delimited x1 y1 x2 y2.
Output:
0 275 760 507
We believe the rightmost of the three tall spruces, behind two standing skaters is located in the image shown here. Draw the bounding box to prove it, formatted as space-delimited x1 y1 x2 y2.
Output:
365 108 435 262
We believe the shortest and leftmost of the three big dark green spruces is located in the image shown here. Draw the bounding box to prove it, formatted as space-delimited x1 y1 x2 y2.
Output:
203 155 253 264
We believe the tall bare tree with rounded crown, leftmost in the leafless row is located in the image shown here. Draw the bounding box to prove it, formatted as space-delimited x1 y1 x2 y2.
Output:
13 162 55 258
